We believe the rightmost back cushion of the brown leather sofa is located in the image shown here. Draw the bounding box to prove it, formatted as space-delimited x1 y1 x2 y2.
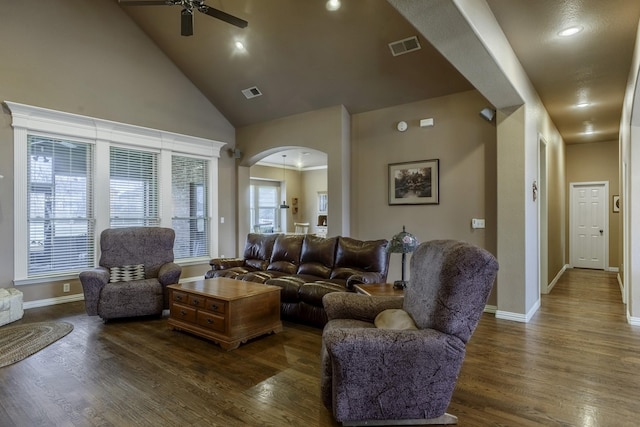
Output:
331 236 389 279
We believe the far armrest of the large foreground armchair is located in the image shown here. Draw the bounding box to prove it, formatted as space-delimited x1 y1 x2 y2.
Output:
322 292 404 323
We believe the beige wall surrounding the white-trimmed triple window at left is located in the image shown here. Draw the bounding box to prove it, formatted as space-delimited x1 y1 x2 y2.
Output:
0 0 235 301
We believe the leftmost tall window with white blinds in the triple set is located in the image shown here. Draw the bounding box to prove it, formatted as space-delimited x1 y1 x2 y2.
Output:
27 135 94 276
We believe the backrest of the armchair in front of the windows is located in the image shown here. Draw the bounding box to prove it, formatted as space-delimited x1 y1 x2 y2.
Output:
99 227 175 278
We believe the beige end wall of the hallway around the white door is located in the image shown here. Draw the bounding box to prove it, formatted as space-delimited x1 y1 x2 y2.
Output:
565 141 621 268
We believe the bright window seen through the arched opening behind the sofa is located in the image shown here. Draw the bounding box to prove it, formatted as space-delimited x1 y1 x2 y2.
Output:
249 180 280 233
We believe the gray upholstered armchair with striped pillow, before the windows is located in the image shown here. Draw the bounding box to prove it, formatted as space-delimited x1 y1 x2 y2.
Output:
80 227 182 321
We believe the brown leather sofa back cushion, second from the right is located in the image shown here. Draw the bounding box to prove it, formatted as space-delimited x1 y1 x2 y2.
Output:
298 234 338 279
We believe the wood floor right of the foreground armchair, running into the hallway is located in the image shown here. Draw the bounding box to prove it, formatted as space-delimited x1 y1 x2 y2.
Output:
449 269 640 426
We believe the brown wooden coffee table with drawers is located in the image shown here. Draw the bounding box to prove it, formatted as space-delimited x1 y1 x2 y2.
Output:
167 277 282 350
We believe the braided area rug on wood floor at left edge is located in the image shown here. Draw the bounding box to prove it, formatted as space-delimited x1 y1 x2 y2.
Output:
0 322 73 368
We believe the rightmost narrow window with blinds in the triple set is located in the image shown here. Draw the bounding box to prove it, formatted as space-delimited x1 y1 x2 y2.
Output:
171 156 209 258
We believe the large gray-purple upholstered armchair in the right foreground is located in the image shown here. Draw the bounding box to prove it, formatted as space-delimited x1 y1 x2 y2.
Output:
321 240 498 425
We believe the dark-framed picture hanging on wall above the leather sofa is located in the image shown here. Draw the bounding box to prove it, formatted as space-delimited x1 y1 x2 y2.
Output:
388 159 440 205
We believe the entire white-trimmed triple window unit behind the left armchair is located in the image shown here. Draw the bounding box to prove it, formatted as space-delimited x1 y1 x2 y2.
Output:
5 101 225 285
